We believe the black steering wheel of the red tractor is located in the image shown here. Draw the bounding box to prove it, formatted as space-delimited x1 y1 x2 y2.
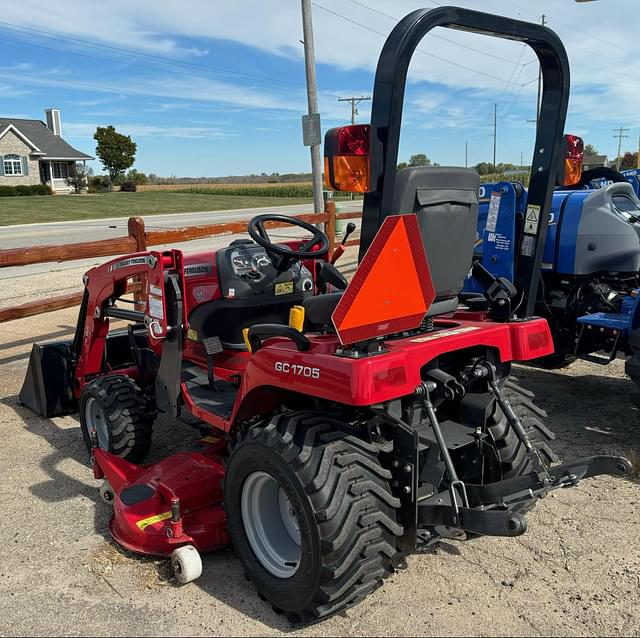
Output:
247 214 329 270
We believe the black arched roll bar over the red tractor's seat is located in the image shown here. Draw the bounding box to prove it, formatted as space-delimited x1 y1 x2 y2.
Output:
360 7 569 316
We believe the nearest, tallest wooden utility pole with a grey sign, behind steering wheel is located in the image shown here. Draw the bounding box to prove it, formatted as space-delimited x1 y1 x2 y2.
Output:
302 0 324 215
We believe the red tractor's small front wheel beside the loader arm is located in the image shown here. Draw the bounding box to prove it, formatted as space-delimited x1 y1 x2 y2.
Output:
79 375 156 463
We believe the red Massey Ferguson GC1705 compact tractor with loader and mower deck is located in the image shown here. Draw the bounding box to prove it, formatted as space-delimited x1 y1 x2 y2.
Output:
21 7 631 622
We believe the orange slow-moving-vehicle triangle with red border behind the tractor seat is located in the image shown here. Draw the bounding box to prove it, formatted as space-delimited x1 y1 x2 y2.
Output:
331 215 435 345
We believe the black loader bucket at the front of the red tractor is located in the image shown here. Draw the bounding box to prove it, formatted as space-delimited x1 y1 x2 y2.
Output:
18 341 76 417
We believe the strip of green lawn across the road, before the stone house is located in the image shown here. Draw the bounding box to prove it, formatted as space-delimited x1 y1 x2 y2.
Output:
0 191 311 226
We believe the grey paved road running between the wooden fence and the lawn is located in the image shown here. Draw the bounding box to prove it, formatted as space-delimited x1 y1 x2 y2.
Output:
0 201 362 248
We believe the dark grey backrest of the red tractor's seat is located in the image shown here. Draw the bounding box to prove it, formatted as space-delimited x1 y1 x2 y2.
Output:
392 166 480 316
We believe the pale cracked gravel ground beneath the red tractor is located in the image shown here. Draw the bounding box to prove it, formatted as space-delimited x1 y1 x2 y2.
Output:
0 310 640 636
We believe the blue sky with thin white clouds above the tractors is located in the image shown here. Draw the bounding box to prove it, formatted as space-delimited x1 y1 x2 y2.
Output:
0 0 640 177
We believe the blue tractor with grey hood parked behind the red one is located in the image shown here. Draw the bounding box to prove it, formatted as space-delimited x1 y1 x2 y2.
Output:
464 160 640 385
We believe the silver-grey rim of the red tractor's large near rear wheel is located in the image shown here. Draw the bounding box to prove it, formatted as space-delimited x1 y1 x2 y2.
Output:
240 472 302 578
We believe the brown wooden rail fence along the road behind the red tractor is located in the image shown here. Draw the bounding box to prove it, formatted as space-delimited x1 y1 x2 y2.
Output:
0 200 361 323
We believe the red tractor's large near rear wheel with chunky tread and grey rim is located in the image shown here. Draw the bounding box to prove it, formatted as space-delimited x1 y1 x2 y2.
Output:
224 412 402 622
